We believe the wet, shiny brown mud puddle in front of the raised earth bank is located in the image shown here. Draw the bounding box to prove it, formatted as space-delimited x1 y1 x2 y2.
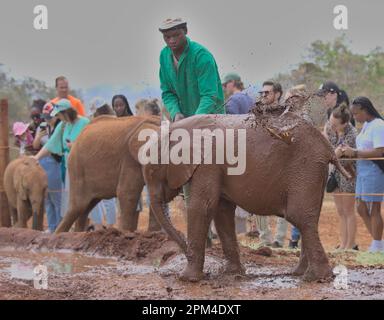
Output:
0 250 384 299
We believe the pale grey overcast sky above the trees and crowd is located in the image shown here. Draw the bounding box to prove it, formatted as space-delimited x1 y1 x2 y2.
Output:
0 0 384 89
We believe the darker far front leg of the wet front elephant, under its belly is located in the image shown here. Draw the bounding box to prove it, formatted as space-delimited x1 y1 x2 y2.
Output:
214 198 245 274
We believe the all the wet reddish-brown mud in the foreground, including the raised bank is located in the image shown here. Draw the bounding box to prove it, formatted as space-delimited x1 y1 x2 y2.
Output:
0 228 384 299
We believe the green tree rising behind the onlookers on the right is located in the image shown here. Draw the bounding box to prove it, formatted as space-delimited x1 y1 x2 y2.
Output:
277 36 384 112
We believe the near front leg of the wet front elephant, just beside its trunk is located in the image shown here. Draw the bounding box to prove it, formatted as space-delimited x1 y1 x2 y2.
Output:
180 167 220 282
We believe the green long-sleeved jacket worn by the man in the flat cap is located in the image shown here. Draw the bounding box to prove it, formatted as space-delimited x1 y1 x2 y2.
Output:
160 38 225 119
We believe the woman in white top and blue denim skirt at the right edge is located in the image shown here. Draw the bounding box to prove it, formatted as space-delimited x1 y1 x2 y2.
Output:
342 97 384 252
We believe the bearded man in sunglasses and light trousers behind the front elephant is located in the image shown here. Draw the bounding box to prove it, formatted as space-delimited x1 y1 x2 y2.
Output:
254 81 288 248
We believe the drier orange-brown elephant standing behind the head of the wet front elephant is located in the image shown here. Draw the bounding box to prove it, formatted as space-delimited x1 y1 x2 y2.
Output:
56 116 160 233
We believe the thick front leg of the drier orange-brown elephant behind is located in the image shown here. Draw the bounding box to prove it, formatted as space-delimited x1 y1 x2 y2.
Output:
117 167 144 231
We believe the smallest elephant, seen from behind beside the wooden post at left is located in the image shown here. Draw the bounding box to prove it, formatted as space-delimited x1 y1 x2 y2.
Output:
4 157 48 230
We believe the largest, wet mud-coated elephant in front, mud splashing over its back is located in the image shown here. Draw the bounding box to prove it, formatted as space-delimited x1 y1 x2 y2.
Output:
144 112 348 281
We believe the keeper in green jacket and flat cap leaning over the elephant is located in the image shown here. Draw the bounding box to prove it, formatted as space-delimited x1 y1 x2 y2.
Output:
159 18 225 245
